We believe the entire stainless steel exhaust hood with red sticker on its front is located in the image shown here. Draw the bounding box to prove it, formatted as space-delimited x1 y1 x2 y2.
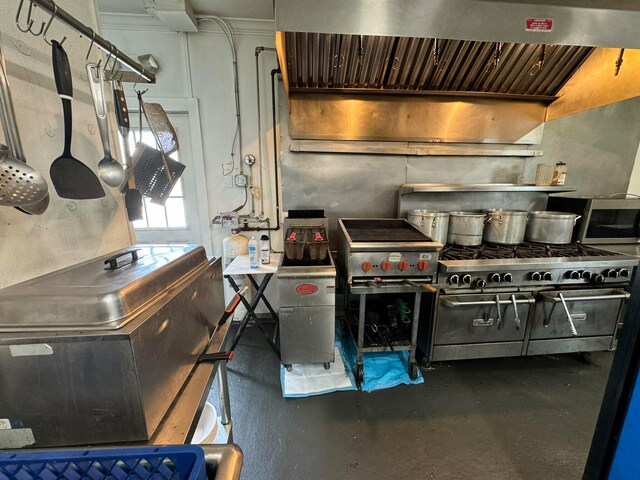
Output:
275 0 640 145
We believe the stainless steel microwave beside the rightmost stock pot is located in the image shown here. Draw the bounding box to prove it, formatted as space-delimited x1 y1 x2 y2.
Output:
547 196 640 244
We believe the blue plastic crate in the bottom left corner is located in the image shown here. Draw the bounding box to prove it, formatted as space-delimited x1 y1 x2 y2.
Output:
0 445 207 480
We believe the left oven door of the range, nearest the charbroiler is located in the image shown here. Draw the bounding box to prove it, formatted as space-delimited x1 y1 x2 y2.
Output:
432 293 535 361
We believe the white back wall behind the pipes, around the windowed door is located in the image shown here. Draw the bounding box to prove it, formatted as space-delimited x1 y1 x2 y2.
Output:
101 14 281 255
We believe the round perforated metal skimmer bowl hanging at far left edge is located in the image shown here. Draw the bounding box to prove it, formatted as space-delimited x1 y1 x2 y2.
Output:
0 144 49 207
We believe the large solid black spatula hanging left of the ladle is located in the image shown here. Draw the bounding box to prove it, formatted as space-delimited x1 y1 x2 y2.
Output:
49 40 105 200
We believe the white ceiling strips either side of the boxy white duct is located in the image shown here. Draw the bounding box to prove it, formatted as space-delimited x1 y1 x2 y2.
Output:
98 0 273 20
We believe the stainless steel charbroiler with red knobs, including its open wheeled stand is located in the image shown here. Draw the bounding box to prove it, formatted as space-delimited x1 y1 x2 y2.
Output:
338 218 442 384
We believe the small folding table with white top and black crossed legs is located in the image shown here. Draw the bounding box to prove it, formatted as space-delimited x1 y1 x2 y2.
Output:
223 253 280 360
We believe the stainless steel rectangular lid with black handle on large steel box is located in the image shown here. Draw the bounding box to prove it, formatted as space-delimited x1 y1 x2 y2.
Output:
0 245 208 332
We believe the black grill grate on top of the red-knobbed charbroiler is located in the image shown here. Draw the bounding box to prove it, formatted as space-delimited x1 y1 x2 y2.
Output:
342 220 431 242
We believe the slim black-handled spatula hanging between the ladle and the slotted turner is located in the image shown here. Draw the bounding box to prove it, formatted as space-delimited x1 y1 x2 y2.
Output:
113 81 144 222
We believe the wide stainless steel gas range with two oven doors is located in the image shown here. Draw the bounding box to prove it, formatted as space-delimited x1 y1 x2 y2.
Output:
419 243 638 361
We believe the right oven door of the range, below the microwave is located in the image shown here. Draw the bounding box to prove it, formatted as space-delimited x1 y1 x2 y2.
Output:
527 288 629 355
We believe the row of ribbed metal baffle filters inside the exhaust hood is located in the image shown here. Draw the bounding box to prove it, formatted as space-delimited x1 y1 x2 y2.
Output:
285 32 593 101
